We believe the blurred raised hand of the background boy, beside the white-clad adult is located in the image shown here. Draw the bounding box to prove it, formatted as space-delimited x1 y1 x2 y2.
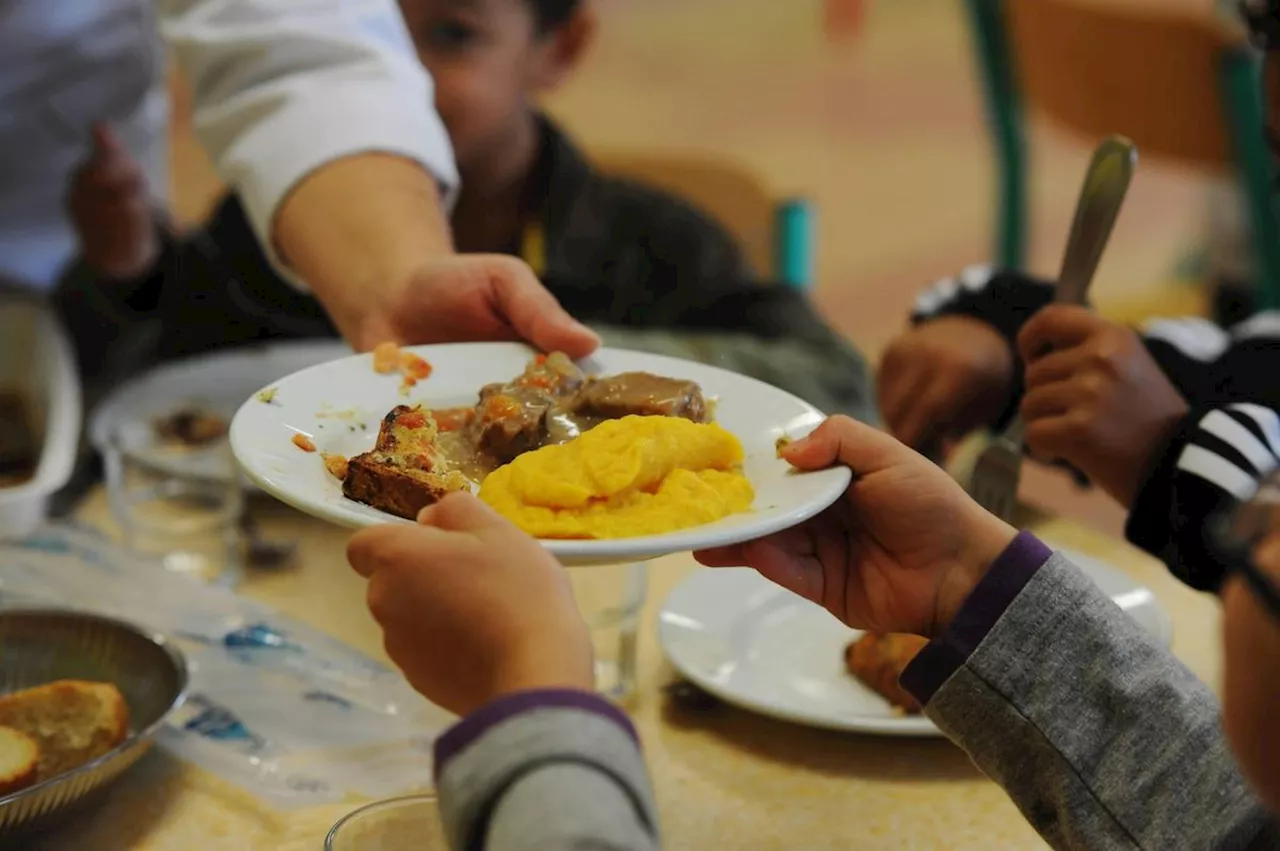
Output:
68 124 160 279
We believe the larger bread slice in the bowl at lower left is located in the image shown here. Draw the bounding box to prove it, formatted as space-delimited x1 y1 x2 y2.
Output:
0 680 129 781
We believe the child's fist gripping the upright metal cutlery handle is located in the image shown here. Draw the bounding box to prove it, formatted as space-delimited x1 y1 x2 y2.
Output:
1018 305 1188 507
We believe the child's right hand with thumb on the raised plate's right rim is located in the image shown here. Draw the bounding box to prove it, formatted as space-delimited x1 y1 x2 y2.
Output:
696 417 1016 636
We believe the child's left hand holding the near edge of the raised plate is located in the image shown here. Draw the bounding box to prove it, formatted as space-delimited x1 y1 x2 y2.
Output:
347 494 594 715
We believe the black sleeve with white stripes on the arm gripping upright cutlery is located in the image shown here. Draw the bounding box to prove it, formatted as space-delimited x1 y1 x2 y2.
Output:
1125 314 1280 590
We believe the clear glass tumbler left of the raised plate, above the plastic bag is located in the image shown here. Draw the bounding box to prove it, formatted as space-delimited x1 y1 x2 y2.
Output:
105 424 244 585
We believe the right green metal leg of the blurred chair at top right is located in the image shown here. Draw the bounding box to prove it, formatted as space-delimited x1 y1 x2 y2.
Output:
1220 47 1280 310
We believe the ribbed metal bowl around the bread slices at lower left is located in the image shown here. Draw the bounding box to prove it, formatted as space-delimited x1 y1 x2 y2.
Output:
0 609 187 842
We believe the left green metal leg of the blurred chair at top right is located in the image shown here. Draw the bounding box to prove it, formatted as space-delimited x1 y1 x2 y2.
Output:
965 0 1027 269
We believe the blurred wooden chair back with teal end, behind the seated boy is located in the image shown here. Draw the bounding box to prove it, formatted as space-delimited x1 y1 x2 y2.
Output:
593 151 817 289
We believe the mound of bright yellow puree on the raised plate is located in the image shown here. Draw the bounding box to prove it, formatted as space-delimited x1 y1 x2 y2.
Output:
480 416 755 539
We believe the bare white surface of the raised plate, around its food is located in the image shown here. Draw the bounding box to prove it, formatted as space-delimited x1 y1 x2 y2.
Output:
230 343 850 564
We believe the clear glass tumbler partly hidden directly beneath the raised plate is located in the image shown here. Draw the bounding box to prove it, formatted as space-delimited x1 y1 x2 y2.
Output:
567 562 649 700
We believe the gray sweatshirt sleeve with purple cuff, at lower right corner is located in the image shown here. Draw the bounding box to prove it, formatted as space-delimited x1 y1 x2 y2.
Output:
902 534 1280 851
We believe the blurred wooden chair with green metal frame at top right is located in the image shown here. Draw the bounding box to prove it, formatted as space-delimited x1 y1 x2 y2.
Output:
966 0 1280 307
